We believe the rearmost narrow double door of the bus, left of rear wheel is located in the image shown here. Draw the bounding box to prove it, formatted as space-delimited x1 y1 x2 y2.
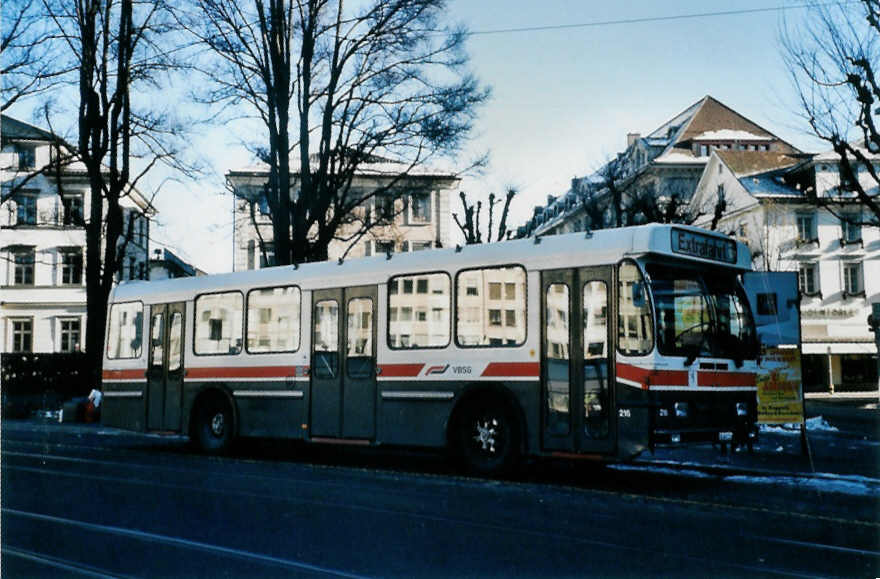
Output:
147 302 185 431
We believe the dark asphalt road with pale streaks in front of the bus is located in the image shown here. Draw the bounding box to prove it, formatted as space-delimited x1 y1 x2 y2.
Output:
0 421 880 577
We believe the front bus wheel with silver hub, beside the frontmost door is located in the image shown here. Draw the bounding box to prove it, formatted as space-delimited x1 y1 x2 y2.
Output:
453 397 520 475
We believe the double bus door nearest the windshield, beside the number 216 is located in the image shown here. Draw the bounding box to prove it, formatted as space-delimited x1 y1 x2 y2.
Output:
541 266 617 454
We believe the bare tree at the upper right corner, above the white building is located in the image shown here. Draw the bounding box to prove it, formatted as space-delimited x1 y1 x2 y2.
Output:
781 0 880 225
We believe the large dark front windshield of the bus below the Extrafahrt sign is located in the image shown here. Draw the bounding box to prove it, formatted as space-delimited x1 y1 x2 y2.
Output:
647 264 757 365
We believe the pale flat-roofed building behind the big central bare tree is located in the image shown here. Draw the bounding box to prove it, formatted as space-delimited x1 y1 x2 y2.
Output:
226 157 459 271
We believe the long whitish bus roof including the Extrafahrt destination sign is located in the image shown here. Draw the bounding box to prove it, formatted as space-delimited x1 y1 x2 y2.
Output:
110 224 751 303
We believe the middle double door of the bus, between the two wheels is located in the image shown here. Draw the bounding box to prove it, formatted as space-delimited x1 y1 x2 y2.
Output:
310 286 378 440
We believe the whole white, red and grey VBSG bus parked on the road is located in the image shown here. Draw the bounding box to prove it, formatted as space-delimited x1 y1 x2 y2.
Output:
102 224 757 473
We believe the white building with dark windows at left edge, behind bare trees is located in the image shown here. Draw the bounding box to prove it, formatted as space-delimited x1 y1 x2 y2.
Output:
0 115 154 352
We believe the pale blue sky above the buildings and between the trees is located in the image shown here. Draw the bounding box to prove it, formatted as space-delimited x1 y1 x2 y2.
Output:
9 0 822 273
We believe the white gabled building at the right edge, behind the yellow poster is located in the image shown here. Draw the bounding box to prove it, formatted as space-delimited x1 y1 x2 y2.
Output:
692 151 880 392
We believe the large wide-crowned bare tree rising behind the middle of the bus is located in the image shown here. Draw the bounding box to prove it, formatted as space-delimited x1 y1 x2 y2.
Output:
179 0 488 264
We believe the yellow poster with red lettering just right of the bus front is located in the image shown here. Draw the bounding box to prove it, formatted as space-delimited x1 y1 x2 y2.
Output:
756 347 804 424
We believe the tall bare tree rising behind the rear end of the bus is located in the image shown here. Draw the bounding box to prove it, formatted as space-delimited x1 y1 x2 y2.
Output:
44 0 193 388
